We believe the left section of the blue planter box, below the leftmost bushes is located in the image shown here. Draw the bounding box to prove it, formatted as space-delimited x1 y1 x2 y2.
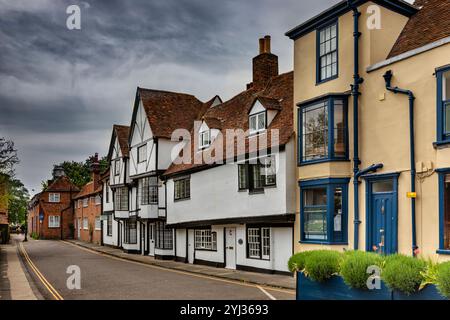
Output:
297 272 392 300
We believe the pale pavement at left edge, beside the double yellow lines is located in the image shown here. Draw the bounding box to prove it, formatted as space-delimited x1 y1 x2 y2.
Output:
0 235 37 300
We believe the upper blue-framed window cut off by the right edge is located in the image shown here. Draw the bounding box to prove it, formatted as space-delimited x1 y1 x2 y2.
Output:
435 66 450 145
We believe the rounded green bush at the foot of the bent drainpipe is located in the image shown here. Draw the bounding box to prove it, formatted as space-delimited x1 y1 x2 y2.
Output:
381 254 427 295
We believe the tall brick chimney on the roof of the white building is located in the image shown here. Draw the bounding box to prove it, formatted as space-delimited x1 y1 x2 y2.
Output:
251 36 278 91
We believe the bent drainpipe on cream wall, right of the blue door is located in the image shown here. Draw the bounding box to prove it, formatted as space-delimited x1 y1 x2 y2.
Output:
383 70 418 256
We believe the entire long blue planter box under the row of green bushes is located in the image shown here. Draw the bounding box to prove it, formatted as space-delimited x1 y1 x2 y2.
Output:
296 272 446 300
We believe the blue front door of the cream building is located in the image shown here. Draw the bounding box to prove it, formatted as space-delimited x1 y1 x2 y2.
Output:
368 179 397 254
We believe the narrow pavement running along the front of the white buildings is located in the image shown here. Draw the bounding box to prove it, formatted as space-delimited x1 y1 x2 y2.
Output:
65 240 295 290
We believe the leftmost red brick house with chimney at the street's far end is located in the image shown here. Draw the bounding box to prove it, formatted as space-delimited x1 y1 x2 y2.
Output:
28 167 80 239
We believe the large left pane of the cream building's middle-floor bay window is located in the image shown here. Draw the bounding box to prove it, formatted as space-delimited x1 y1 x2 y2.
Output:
303 102 328 161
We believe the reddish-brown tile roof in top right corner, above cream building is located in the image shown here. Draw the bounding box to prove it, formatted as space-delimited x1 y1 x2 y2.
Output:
388 0 450 58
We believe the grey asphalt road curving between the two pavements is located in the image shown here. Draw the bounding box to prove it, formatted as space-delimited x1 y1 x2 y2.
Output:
19 240 295 300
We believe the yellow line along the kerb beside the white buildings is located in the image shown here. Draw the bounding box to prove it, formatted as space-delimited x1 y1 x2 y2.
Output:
59 240 295 298
